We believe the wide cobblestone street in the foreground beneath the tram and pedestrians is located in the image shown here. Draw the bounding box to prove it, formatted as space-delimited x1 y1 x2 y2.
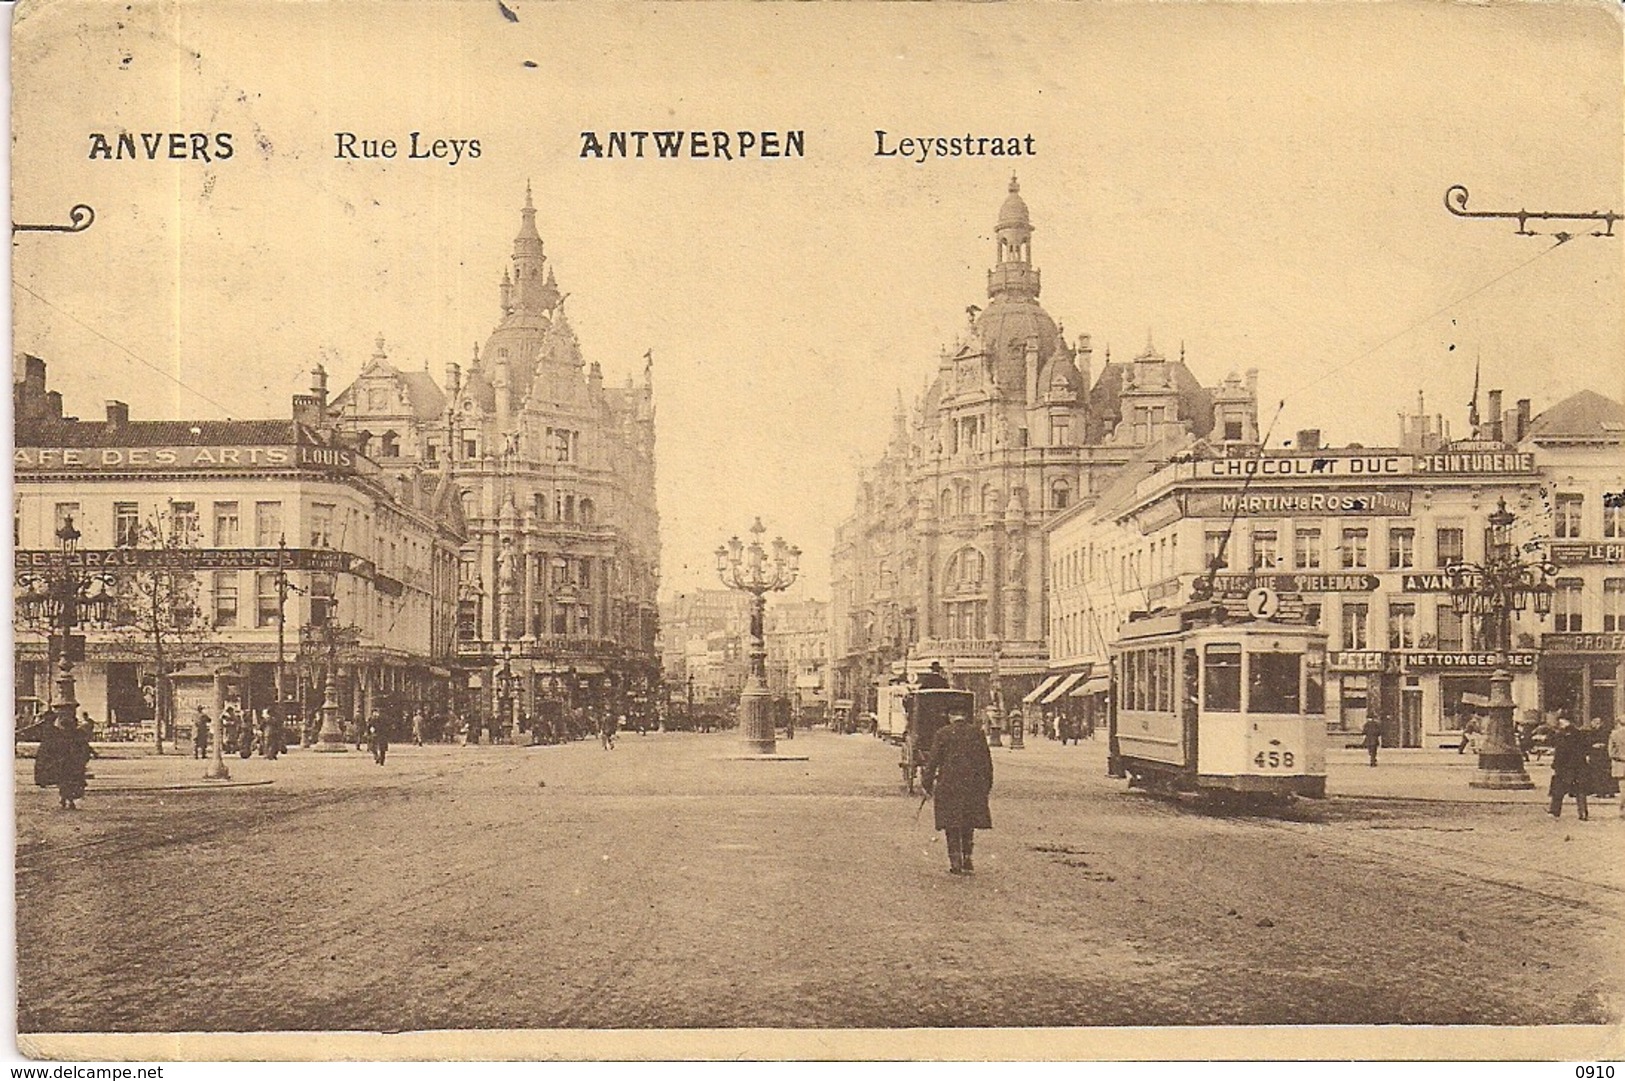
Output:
16 732 1625 1032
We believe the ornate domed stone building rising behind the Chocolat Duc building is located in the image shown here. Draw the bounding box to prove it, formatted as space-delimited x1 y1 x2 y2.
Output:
830 179 1258 709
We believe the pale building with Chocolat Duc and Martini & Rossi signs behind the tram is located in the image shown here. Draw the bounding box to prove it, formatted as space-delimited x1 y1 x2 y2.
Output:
1050 393 1625 746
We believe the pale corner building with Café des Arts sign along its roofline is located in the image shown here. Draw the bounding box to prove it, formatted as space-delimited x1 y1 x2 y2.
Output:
13 356 463 738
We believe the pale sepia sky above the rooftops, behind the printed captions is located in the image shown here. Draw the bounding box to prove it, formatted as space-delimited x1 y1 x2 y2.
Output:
11 0 1625 597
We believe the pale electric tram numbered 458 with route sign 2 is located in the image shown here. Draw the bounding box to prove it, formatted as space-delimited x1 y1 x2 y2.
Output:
1108 601 1326 798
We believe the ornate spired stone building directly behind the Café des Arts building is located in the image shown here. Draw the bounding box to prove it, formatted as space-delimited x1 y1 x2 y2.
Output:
335 185 660 720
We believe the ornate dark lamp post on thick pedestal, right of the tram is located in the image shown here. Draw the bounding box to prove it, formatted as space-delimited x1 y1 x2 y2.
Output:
1448 499 1557 788
